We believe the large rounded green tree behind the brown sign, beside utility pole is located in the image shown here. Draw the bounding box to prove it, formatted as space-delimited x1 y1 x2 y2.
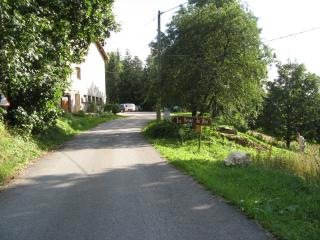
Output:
157 1 270 127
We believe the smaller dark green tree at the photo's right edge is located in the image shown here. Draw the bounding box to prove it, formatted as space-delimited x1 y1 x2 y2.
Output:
261 62 320 147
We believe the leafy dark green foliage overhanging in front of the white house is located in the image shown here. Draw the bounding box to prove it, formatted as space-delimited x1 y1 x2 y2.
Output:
0 0 117 130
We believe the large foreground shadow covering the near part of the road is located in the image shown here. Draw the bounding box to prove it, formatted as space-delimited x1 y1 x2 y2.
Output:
0 160 266 240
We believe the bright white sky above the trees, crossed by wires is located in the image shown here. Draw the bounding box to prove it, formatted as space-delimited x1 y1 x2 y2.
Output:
106 0 320 78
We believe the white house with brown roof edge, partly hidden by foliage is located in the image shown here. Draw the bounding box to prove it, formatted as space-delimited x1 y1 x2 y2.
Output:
61 42 108 112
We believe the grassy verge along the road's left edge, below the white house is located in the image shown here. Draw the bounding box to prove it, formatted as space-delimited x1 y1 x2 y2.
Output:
0 114 120 187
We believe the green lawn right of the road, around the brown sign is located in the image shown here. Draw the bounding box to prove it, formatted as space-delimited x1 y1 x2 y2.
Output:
145 123 320 240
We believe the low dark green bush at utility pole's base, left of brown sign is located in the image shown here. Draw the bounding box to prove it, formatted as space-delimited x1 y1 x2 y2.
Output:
145 121 179 138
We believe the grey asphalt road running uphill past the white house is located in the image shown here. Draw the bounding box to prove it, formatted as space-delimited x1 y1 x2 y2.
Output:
0 113 268 240
